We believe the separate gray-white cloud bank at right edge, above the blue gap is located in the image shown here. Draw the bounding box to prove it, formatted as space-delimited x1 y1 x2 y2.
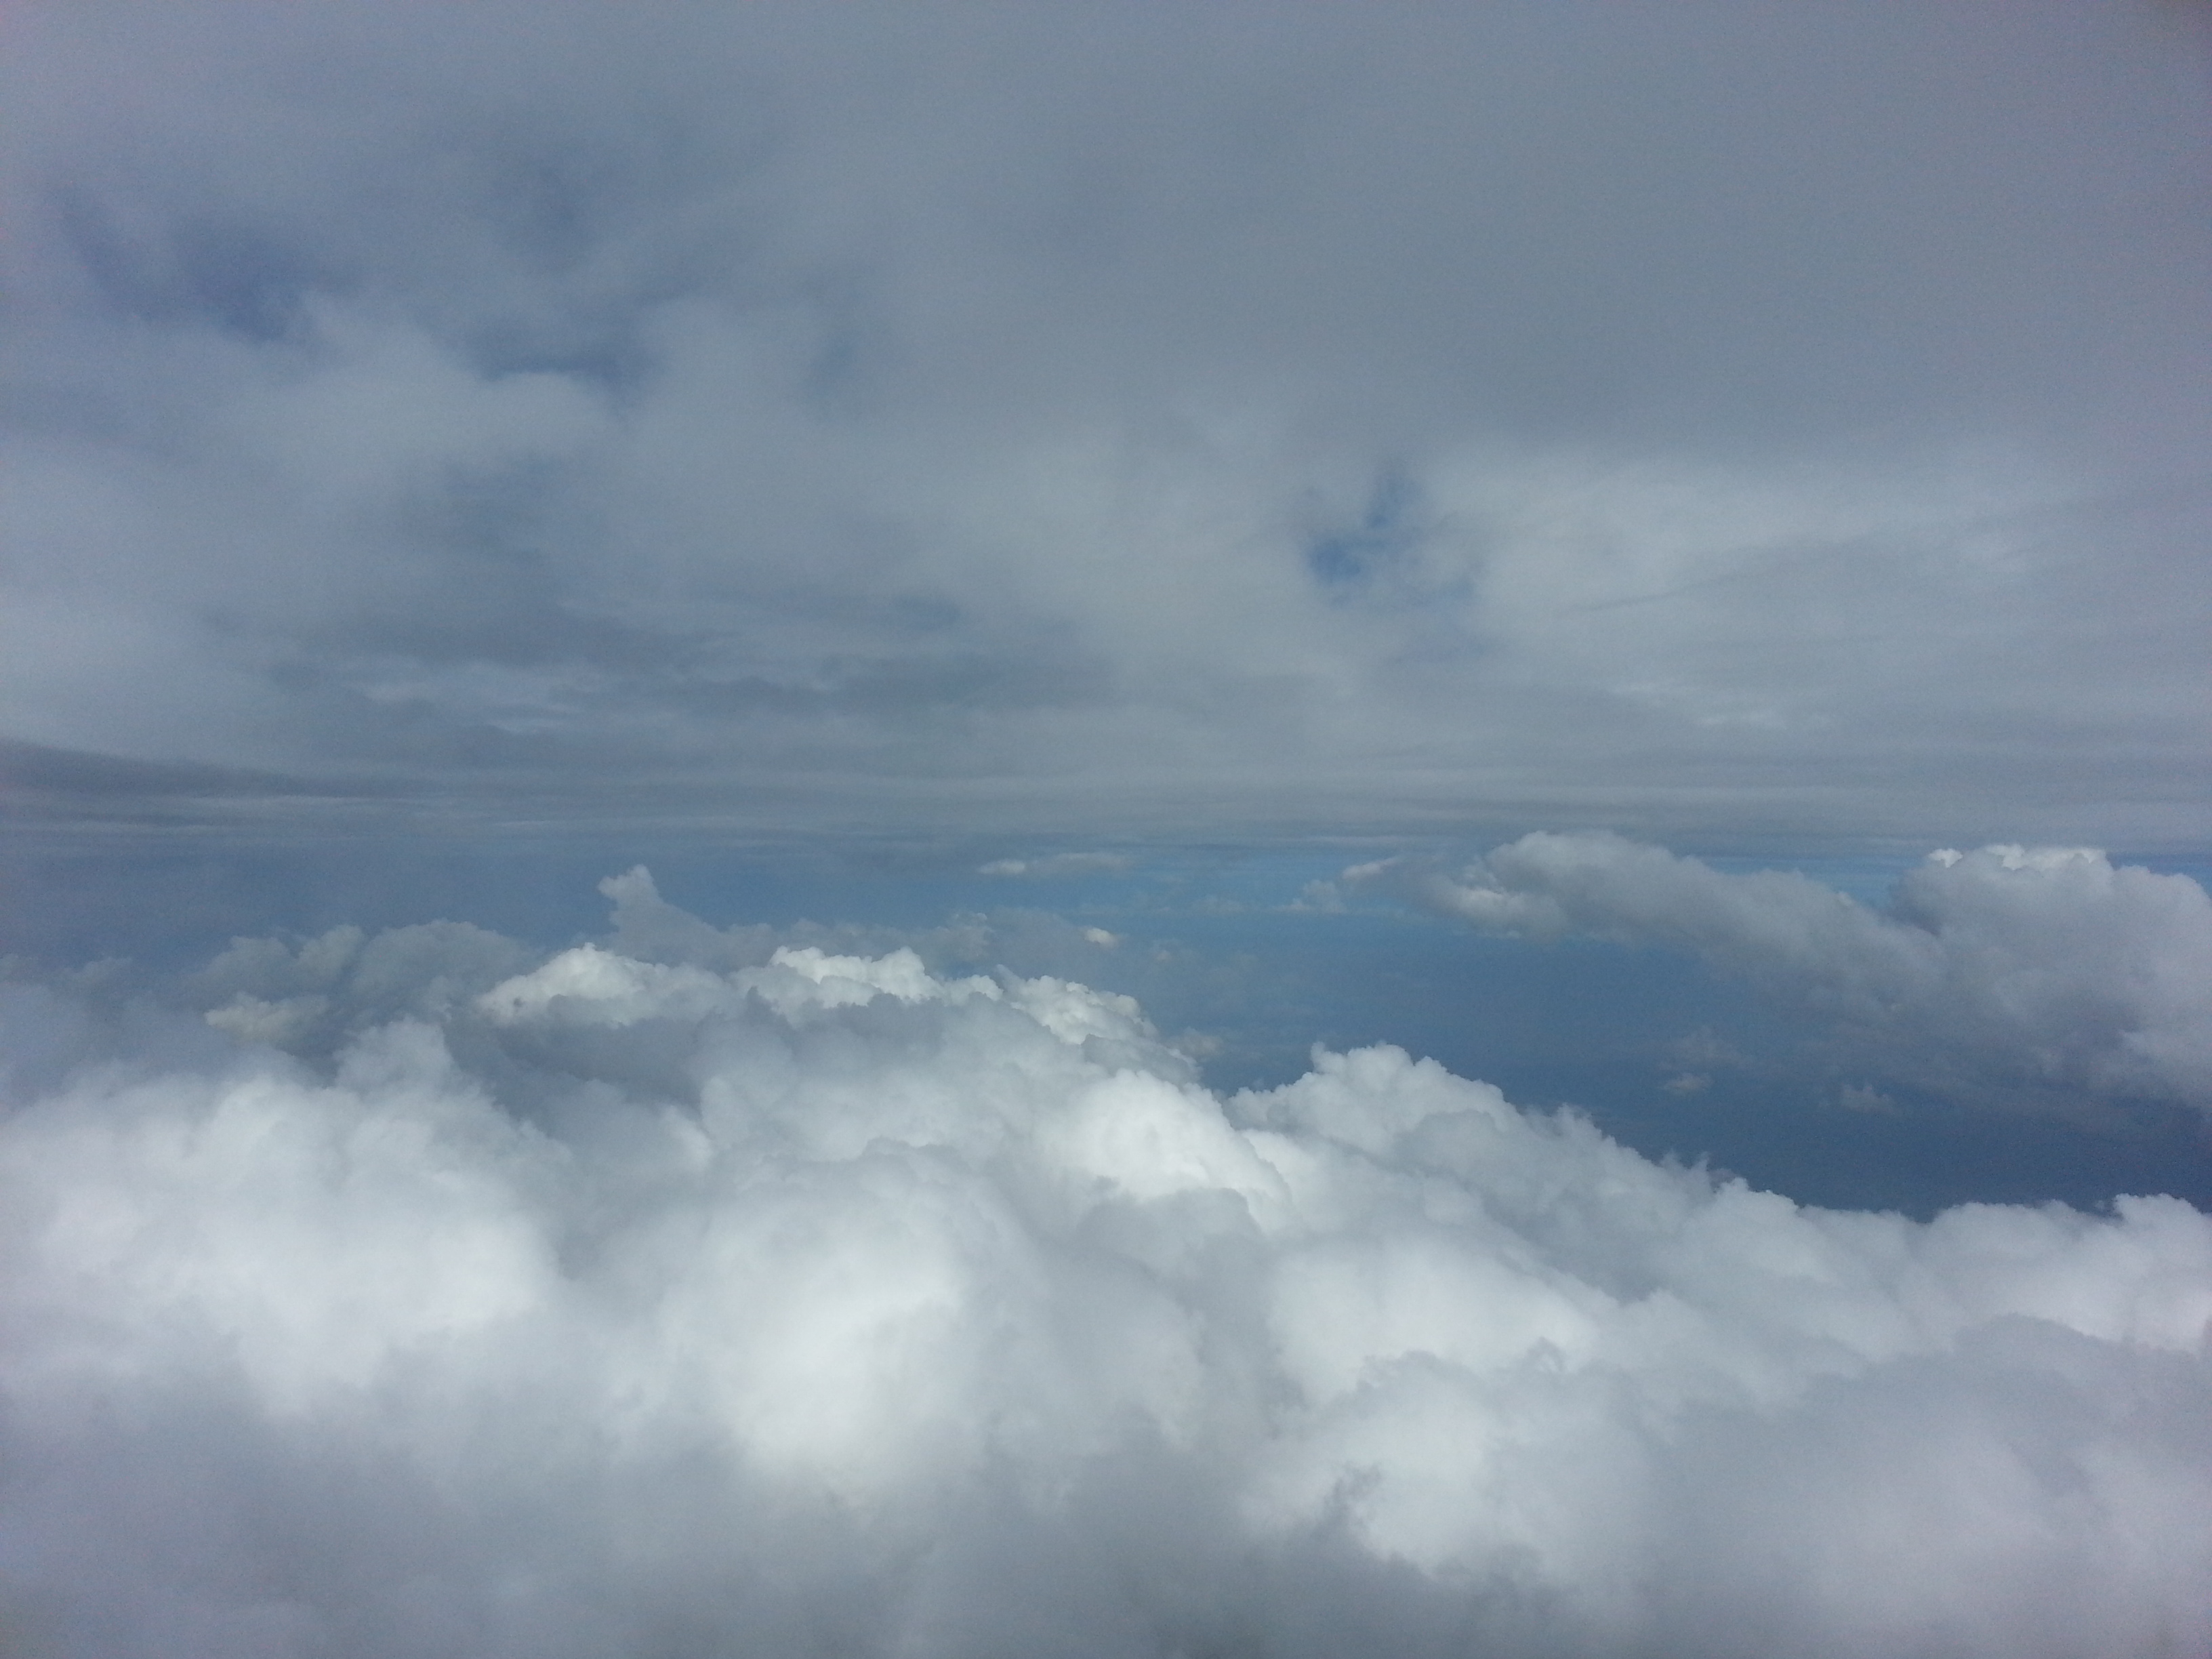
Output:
1347 834 2212 1111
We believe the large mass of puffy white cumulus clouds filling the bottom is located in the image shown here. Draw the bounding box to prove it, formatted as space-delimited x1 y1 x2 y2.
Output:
0 898 2212 1659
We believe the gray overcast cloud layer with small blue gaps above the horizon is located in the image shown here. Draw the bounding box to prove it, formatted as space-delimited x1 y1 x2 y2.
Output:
0 0 2212 852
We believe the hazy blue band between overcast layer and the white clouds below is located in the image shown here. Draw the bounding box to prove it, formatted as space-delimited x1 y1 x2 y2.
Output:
9 840 2212 1214
